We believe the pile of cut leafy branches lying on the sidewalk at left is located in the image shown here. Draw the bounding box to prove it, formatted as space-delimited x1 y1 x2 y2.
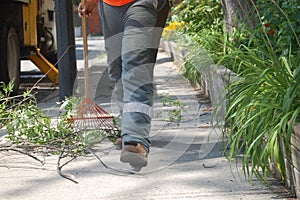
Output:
0 83 122 183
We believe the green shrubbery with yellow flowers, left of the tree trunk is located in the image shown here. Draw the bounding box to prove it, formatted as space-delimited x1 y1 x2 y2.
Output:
165 0 223 85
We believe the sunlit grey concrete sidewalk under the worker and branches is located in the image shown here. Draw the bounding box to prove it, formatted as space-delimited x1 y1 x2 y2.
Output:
0 38 291 200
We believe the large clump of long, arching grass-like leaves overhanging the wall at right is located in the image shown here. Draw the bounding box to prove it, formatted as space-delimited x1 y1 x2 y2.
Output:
226 45 300 180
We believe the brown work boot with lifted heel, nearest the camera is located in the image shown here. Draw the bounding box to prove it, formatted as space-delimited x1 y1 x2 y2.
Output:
120 142 148 170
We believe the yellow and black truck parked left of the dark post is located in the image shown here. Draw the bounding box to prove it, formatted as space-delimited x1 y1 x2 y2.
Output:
0 0 58 94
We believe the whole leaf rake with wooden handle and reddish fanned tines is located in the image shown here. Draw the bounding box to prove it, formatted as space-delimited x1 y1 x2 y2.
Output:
71 0 120 137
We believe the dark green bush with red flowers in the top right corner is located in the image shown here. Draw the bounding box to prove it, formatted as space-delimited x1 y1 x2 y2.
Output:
257 0 300 56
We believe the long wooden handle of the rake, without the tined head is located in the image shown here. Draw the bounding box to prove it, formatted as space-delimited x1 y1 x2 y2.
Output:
81 0 90 98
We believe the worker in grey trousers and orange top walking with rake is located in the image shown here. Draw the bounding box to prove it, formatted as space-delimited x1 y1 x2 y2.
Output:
78 0 169 169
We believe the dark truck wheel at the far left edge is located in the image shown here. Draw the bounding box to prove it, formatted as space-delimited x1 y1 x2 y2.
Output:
0 25 20 94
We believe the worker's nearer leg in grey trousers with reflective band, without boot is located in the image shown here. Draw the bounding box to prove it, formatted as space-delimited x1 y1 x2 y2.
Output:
122 0 167 151
